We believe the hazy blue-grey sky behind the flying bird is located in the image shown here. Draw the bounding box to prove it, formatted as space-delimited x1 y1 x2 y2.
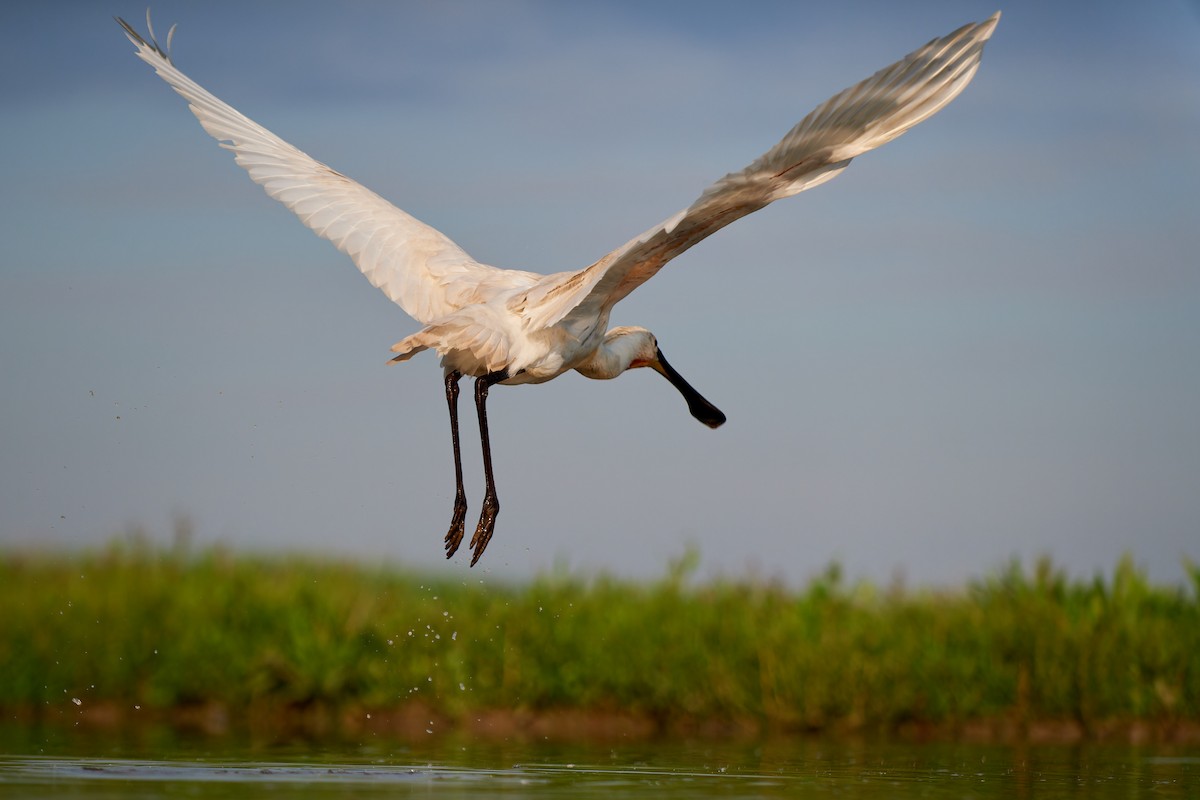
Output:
0 0 1200 583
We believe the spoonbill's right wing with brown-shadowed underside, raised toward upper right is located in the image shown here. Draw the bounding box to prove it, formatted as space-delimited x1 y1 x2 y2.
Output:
512 12 1000 330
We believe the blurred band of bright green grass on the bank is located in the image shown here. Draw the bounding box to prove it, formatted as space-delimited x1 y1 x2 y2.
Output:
0 545 1200 732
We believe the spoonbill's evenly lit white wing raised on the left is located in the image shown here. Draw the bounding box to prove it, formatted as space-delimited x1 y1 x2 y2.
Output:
116 12 516 323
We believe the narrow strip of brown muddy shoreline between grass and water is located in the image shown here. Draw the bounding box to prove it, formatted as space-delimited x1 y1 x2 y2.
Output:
9 700 1200 745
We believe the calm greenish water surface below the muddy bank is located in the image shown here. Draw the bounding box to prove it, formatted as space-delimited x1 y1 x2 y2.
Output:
0 728 1200 800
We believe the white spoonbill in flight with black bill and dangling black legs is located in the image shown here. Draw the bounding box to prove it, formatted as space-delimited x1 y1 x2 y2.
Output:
116 11 1000 566
